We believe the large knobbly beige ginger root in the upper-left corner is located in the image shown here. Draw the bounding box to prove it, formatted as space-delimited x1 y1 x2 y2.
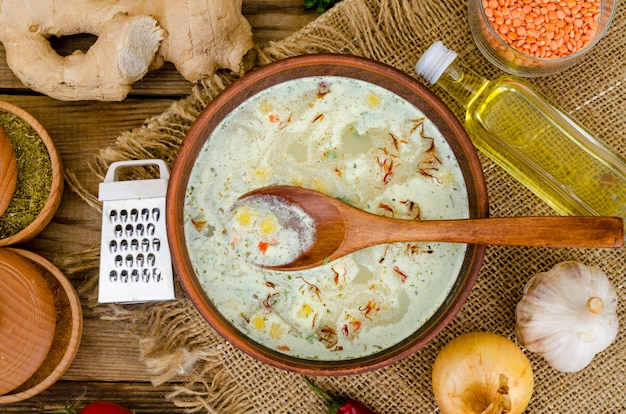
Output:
0 0 254 101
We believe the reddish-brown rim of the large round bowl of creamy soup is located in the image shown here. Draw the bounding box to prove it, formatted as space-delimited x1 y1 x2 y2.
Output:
166 54 488 375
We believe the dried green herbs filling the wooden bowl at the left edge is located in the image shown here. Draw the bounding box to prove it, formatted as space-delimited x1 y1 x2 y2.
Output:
0 111 52 239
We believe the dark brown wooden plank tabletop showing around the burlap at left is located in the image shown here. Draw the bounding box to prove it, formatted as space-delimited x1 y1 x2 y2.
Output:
0 0 317 414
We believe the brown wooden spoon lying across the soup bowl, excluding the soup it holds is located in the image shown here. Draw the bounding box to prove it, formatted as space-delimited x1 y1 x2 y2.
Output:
240 186 624 270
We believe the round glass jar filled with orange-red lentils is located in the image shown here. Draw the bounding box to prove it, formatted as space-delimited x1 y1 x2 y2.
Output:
468 0 616 77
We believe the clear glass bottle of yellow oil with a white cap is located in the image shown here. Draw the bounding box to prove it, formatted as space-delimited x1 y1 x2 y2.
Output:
415 42 626 222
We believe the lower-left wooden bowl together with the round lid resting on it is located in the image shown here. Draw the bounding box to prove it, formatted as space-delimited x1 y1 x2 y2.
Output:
0 248 83 404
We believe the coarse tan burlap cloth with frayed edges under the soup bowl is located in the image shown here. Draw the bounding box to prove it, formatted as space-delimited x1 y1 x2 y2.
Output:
67 0 626 414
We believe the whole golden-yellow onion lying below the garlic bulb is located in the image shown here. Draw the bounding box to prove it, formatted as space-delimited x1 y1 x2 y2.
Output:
432 332 534 414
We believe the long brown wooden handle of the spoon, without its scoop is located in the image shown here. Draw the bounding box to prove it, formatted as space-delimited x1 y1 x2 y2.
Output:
354 216 624 248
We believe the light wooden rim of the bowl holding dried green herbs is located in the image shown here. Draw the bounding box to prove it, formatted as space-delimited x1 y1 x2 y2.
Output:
0 101 64 246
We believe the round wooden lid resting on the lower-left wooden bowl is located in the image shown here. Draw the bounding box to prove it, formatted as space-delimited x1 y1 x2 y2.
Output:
0 248 56 395
